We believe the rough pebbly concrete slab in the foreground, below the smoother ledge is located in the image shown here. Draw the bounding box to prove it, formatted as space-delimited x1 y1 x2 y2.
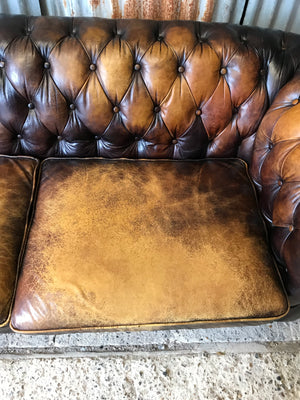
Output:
0 352 300 400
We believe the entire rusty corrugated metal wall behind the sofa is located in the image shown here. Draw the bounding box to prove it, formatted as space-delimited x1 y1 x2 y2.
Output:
0 0 300 33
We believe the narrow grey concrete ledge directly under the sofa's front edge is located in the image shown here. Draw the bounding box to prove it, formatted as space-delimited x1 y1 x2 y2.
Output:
0 319 300 358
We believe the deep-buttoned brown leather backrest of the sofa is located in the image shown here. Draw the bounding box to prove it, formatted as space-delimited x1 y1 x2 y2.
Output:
0 16 300 160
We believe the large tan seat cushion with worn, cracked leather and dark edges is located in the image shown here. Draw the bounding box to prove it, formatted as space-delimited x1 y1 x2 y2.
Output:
12 159 288 331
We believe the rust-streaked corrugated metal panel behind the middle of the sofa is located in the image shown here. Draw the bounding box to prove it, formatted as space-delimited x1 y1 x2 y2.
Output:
41 0 245 23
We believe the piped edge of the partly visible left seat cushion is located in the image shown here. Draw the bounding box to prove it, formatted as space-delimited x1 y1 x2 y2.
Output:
0 154 40 328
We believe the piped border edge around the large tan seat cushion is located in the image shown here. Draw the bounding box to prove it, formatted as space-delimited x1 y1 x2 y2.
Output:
9 157 290 335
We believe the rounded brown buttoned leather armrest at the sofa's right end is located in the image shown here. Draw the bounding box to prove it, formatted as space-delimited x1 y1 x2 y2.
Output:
251 71 300 304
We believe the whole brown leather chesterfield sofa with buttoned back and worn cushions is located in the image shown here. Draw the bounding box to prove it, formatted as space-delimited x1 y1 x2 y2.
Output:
0 15 300 333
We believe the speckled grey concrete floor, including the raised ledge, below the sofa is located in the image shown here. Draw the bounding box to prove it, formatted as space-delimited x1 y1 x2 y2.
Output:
0 320 300 400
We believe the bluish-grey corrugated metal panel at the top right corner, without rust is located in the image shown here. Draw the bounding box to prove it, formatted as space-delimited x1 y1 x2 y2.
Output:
244 0 300 33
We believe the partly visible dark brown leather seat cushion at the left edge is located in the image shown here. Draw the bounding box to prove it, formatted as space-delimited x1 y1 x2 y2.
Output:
0 156 38 326
